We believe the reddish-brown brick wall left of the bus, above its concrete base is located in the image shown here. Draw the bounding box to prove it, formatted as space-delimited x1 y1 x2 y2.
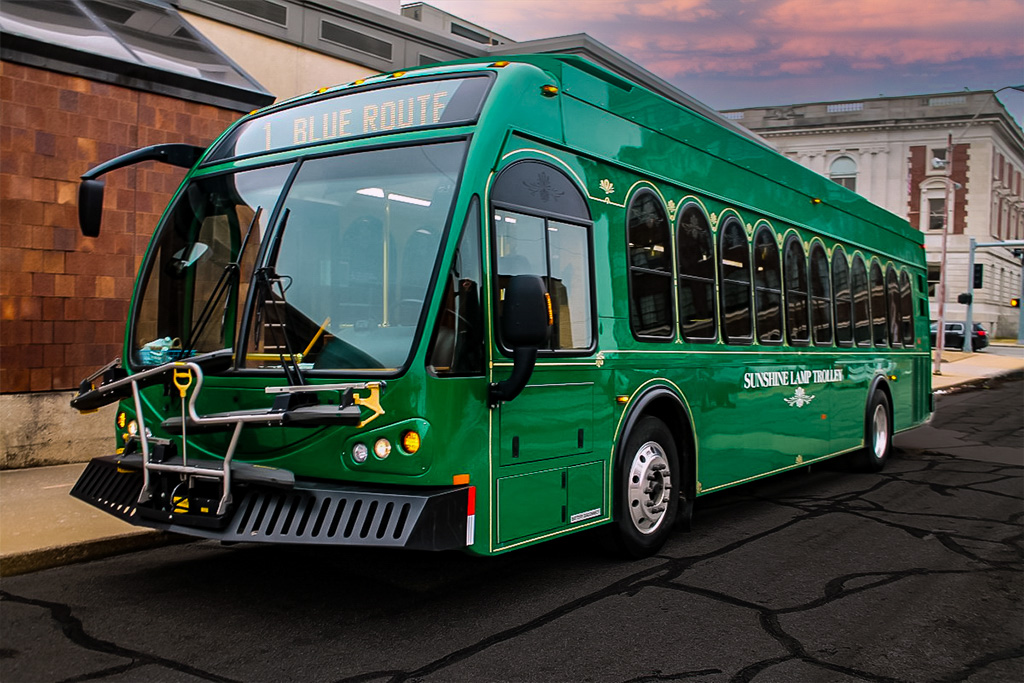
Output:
0 61 240 393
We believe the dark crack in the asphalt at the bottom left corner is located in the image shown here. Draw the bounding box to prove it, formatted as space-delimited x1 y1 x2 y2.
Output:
0 590 238 683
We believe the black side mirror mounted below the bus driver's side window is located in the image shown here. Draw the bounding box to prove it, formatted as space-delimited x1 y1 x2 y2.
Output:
487 275 552 408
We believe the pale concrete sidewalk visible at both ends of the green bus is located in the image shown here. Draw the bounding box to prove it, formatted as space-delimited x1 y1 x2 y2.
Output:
0 345 1024 577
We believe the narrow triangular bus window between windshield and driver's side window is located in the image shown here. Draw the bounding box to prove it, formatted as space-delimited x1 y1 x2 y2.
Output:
427 197 483 376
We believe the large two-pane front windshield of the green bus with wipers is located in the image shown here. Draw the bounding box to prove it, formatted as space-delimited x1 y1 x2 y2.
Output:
132 141 466 372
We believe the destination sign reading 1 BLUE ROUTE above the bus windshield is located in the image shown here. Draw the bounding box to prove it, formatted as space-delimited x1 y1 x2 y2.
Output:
210 78 489 160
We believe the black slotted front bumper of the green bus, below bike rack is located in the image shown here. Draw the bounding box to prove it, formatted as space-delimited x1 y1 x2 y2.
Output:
71 456 471 550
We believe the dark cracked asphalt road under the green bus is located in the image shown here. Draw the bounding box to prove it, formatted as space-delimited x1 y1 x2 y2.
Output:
0 379 1024 683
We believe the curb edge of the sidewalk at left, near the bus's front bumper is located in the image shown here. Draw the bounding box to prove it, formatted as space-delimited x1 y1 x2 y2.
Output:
0 531 190 578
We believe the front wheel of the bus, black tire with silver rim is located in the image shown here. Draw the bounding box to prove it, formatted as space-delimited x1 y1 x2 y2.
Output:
609 416 685 558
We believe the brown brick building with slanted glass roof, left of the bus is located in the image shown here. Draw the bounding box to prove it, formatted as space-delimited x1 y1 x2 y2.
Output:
0 0 273 466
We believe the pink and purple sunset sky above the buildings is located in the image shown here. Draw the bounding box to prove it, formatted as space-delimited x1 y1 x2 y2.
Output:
415 0 1024 123
